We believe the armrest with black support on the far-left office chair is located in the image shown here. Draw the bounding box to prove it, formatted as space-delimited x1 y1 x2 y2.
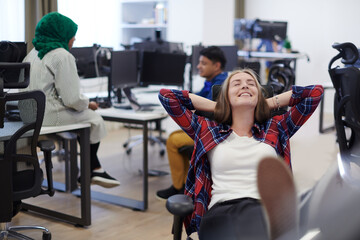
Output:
38 140 55 197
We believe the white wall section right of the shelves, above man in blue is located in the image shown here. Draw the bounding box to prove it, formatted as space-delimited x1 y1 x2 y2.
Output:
168 0 235 50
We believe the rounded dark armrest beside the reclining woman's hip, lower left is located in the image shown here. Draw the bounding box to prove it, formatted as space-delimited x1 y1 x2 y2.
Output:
166 194 194 217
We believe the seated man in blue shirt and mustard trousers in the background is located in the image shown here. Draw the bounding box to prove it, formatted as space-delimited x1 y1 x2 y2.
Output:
156 46 227 200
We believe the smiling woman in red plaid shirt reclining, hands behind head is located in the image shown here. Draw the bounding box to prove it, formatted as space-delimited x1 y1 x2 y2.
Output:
159 69 324 240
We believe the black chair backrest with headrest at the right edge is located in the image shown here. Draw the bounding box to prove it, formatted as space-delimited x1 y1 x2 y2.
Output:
329 43 360 158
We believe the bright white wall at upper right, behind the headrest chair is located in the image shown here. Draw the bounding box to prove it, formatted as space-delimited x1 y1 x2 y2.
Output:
245 0 360 112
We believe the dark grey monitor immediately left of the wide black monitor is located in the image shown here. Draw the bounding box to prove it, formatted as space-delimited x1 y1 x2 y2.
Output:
109 50 139 89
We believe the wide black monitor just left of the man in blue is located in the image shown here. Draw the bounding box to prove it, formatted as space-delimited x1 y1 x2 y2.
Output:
140 51 186 86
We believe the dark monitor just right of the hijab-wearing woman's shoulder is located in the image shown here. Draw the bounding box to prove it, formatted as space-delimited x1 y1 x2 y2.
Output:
70 45 97 78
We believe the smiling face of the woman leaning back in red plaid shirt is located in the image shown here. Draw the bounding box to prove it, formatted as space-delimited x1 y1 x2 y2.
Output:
228 72 259 109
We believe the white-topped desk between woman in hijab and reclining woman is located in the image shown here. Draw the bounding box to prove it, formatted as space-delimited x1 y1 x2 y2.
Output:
91 108 168 211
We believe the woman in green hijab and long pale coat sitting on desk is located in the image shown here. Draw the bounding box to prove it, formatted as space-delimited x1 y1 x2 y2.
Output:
19 12 120 187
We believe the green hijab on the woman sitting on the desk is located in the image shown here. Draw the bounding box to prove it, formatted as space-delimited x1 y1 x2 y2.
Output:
32 12 78 59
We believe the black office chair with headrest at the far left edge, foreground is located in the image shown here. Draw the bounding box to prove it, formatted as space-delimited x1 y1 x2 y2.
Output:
0 62 54 240
